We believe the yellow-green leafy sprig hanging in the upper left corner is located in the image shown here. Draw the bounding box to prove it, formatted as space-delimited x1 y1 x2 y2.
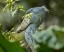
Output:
3 0 25 17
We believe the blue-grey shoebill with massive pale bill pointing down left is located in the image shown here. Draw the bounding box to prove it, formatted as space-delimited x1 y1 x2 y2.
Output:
16 6 49 52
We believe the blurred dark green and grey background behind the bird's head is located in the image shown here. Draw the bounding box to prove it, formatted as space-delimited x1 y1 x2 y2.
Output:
0 0 64 52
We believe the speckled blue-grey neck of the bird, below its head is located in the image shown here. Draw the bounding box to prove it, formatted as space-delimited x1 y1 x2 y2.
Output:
25 24 38 48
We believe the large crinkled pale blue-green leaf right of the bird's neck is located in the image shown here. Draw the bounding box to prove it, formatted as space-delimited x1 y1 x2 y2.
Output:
33 25 64 52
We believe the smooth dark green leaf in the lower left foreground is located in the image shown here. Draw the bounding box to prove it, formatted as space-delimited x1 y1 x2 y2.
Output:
0 25 24 52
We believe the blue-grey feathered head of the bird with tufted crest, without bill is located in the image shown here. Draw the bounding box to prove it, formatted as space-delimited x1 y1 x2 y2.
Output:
26 6 49 25
